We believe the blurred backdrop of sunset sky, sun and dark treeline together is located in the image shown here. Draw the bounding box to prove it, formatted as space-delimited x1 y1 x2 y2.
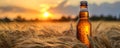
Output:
0 0 120 21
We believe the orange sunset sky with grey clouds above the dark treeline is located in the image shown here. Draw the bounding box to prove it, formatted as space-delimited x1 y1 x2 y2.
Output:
0 0 120 19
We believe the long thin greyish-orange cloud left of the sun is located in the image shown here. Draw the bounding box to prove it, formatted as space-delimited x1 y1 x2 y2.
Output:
0 6 38 13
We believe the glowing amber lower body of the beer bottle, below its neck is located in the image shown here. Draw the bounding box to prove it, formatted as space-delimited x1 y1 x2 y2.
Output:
77 19 91 47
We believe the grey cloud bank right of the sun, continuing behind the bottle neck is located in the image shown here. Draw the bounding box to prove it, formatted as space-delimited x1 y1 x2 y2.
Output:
49 0 120 15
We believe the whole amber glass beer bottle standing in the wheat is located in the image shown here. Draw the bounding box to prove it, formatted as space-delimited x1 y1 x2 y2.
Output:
77 1 91 48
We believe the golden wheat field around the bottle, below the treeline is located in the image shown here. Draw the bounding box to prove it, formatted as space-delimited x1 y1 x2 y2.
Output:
0 21 120 48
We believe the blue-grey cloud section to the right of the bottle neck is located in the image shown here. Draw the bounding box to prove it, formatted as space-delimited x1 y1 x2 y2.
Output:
89 2 120 15
